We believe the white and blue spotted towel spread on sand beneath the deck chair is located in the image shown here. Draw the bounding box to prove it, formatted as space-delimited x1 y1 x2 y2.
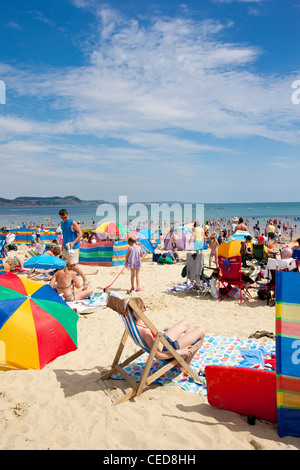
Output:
112 333 275 396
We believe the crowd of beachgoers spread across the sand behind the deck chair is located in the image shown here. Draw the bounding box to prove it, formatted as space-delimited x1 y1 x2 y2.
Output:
2 209 300 301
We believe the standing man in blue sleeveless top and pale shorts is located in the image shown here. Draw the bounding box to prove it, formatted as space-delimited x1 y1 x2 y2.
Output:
59 209 88 288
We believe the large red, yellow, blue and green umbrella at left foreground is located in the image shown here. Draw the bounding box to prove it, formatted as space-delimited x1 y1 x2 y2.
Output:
0 273 78 370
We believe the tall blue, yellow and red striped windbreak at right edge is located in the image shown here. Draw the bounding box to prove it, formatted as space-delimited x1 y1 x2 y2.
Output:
276 271 300 437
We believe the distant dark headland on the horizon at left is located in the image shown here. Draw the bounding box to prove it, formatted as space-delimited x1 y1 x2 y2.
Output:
0 196 107 207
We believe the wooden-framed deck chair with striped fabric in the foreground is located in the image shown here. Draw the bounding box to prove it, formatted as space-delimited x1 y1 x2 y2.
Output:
97 299 203 405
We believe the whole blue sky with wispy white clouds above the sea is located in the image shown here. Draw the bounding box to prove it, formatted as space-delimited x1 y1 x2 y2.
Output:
0 0 300 203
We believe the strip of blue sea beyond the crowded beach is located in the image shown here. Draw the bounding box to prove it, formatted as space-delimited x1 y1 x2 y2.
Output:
0 202 300 232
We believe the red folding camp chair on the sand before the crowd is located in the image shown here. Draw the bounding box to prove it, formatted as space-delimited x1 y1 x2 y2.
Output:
218 256 252 303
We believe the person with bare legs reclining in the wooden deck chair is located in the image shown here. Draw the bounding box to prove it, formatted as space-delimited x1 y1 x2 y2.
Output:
133 297 205 372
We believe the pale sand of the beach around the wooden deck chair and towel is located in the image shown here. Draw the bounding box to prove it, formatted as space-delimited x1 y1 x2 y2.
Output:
0 246 300 451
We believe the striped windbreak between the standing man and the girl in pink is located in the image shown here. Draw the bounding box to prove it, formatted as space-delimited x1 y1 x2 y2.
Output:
79 240 128 266
